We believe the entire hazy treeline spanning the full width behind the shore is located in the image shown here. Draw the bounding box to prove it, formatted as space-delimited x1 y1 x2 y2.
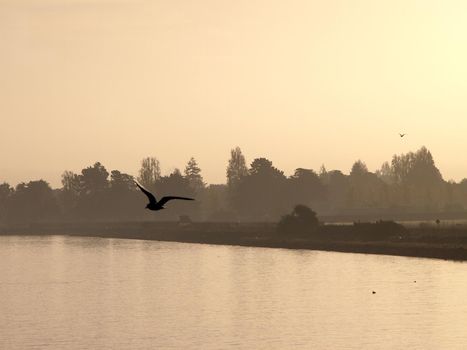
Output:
0 147 467 224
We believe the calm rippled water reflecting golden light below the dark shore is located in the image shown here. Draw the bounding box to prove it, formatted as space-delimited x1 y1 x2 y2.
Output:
0 236 467 350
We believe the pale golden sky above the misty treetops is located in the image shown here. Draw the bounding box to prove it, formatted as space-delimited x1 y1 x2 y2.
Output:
0 0 467 187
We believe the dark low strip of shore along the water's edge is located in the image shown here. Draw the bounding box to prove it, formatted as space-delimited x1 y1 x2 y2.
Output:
0 222 467 261
